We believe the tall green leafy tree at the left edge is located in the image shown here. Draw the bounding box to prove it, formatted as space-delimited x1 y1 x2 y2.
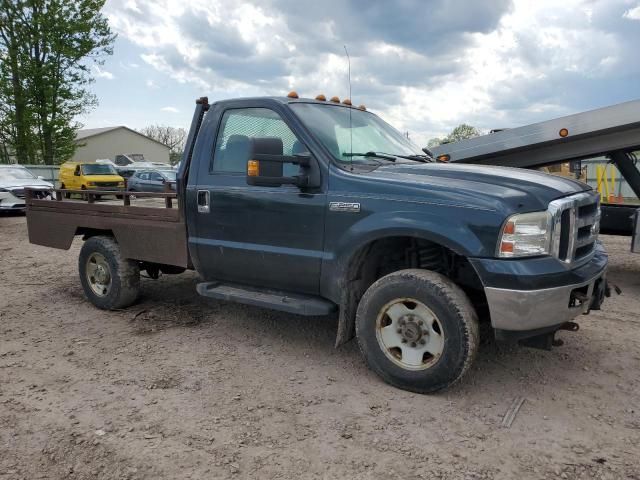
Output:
0 0 115 164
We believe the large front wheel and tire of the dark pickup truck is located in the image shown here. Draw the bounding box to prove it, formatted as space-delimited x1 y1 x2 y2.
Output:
356 269 480 393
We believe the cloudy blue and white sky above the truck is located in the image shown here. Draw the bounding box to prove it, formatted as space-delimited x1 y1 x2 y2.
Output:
81 0 640 145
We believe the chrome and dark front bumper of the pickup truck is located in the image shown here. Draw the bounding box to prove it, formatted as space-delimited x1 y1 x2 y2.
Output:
472 244 607 336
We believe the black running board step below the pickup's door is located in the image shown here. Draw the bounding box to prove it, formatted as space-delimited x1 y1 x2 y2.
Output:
196 282 336 316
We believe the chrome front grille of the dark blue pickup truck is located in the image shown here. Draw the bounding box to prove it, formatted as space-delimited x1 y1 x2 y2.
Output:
549 192 600 263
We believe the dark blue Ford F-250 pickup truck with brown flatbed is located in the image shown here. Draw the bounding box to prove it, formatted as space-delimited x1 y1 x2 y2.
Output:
27 93 608 392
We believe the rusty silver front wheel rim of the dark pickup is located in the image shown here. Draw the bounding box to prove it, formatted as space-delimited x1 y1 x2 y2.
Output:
376 298 444 370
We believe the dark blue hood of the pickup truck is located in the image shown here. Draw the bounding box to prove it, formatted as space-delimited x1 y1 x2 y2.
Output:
368 163 591 211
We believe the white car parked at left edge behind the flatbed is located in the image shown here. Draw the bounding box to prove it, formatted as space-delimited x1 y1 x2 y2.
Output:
0 165 53 212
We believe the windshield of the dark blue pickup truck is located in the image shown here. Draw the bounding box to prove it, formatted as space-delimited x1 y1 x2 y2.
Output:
291 103 425 164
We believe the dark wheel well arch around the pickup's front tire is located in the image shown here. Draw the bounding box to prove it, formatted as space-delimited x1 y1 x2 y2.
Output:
336 234 488 346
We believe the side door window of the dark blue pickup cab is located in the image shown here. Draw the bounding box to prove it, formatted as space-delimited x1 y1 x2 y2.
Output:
211 108 307 176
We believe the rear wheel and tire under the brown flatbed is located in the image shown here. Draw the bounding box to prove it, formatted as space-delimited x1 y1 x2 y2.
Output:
78 236 140 310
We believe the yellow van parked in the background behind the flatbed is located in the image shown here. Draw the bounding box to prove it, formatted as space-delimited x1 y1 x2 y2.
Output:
59 162 125 196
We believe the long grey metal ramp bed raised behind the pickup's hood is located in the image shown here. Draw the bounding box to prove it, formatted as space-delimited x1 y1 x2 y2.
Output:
431 100 640 170
